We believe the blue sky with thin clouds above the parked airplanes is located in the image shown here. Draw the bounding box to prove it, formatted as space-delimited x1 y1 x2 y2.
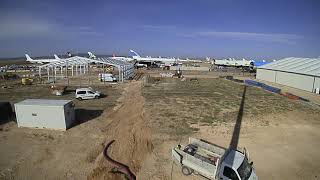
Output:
0 0 320 59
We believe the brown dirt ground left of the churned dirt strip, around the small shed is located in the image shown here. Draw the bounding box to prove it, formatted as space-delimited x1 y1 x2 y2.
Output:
0 82 123 179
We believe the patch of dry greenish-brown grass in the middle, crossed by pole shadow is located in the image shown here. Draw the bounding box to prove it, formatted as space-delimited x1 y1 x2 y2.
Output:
143 78 308 136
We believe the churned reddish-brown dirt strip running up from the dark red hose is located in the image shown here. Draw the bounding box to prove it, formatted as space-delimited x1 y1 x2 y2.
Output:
88 81 153 179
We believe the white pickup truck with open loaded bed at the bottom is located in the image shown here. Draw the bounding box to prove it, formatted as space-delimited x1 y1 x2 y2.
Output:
172 138 258 180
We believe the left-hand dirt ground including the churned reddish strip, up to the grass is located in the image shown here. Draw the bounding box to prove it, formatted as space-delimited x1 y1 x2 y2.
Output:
0 81 153 179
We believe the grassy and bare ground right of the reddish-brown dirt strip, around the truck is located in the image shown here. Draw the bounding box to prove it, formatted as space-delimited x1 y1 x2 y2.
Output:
140 79 320 179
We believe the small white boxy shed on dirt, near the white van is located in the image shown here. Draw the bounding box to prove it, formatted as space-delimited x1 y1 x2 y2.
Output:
14 99 75 130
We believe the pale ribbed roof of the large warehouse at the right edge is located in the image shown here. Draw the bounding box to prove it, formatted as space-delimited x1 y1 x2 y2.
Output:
258 57 320 77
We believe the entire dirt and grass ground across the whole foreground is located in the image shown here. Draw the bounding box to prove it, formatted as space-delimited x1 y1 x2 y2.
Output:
0 73 320 180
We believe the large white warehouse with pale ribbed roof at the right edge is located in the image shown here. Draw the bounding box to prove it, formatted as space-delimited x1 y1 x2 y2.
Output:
257 57 320 92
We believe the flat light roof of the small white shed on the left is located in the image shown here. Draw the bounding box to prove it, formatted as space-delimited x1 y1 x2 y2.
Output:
15 99 71 106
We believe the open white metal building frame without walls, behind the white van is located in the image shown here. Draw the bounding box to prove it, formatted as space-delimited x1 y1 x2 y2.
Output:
38 56 134 82
